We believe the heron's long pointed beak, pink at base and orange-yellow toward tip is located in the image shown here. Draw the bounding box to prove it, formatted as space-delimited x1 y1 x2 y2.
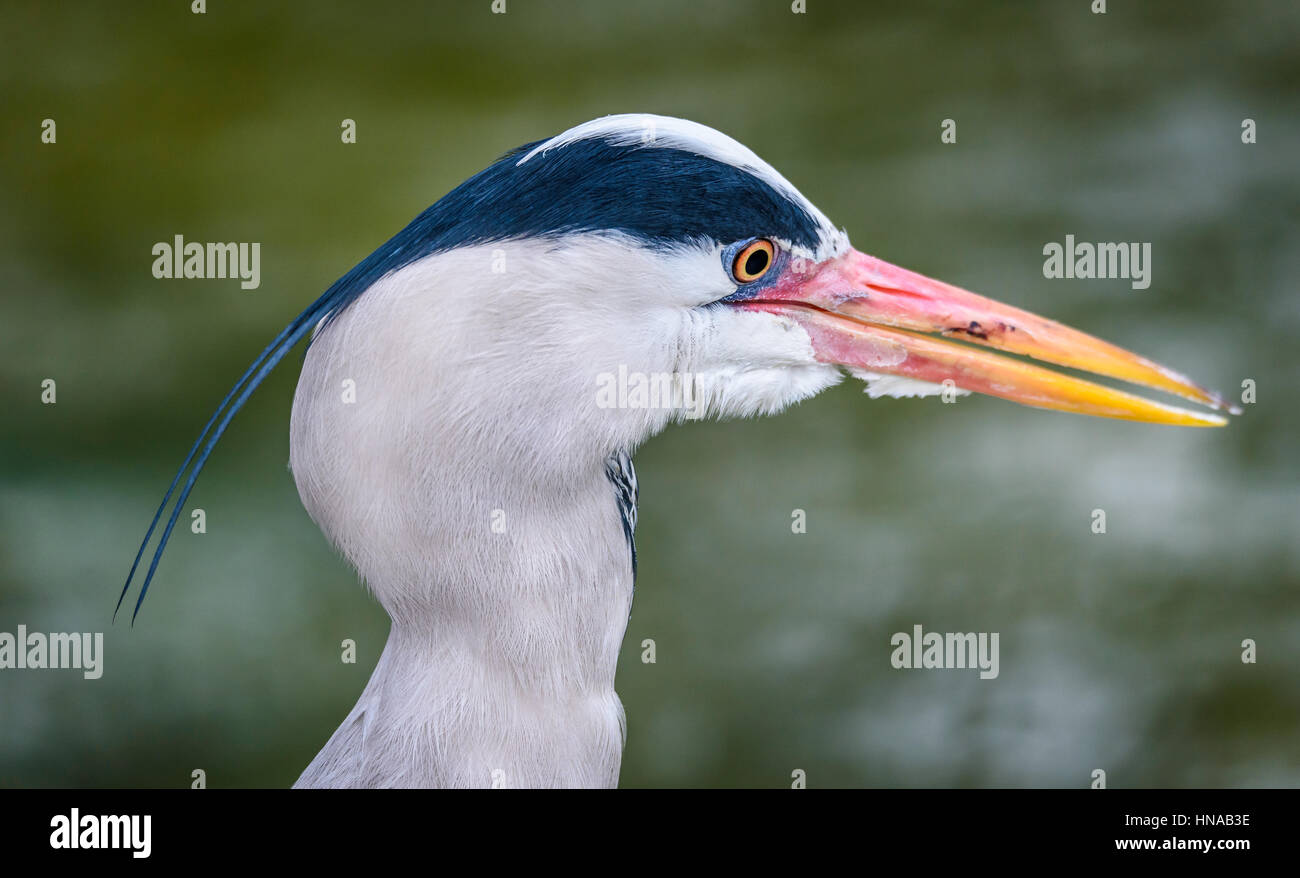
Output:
738 250 1240 427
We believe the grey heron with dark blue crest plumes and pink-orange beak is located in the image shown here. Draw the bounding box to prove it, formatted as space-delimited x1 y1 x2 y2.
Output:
118 114 1234 787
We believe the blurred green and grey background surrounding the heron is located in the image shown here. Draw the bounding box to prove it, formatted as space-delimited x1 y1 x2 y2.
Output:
0 0 1300 787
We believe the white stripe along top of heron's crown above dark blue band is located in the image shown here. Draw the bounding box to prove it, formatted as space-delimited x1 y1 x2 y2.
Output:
515 113 848 258
